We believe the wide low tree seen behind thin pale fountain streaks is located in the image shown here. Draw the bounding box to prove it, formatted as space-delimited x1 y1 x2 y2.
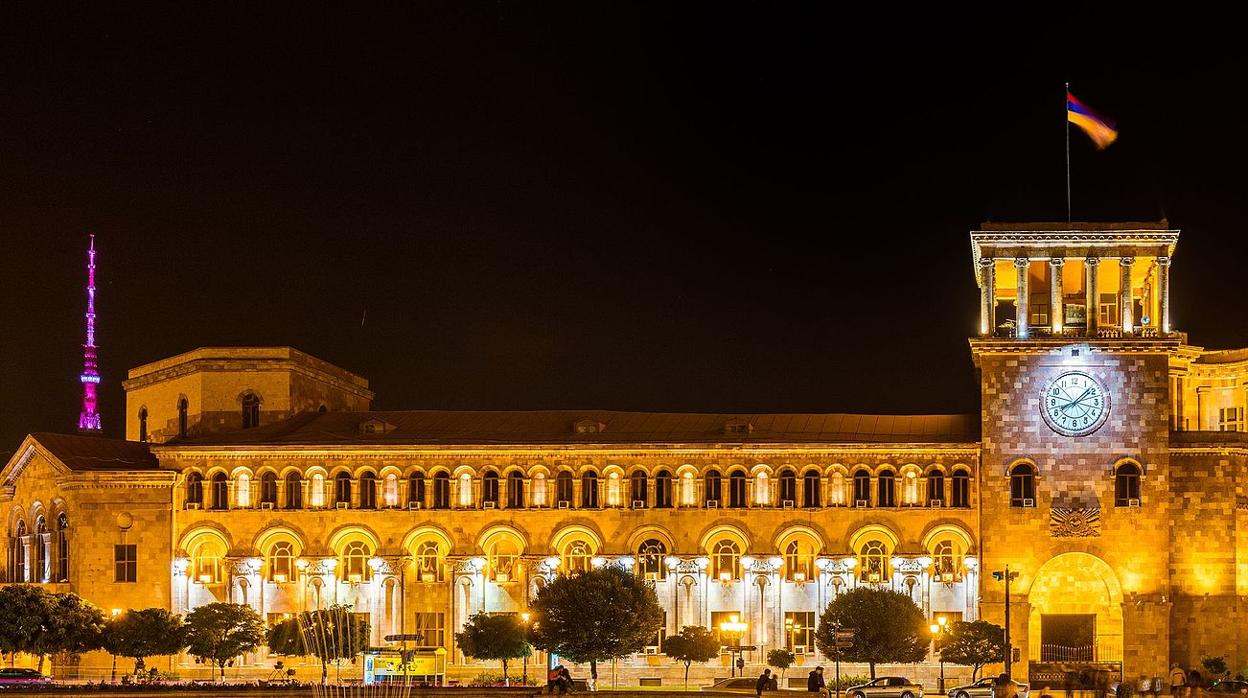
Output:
265 604 371 684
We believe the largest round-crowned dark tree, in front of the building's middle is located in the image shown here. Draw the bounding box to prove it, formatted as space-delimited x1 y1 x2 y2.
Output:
533 567 663 682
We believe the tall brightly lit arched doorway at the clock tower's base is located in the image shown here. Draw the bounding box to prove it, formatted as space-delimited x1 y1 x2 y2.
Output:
1027 553 1122 672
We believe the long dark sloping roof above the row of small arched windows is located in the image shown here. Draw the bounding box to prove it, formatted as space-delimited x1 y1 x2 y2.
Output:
168 410 980 446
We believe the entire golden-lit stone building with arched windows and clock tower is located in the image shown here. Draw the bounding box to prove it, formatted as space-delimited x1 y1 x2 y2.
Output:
2 222 1248 688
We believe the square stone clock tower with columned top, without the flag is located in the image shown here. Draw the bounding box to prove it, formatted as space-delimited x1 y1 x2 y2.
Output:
971 221 1183 686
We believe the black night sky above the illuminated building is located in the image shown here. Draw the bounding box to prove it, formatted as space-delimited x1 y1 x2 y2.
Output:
0 1 1248 452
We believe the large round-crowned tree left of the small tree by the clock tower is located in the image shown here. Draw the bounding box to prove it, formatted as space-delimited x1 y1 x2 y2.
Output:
815 587 927 678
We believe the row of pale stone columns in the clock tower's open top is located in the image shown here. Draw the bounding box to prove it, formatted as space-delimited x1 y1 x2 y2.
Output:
980 257 1171 340
